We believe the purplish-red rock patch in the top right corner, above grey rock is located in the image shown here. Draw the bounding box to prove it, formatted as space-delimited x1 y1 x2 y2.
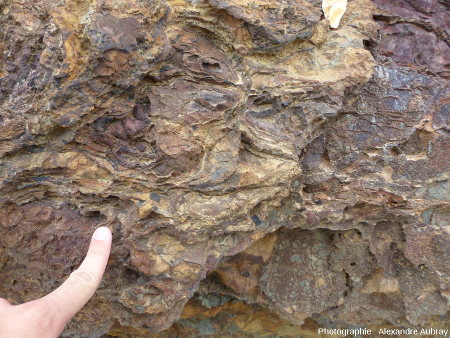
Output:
374 0 450 78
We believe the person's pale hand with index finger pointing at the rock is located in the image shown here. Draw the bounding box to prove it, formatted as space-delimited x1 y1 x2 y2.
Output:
0 227 112 338
